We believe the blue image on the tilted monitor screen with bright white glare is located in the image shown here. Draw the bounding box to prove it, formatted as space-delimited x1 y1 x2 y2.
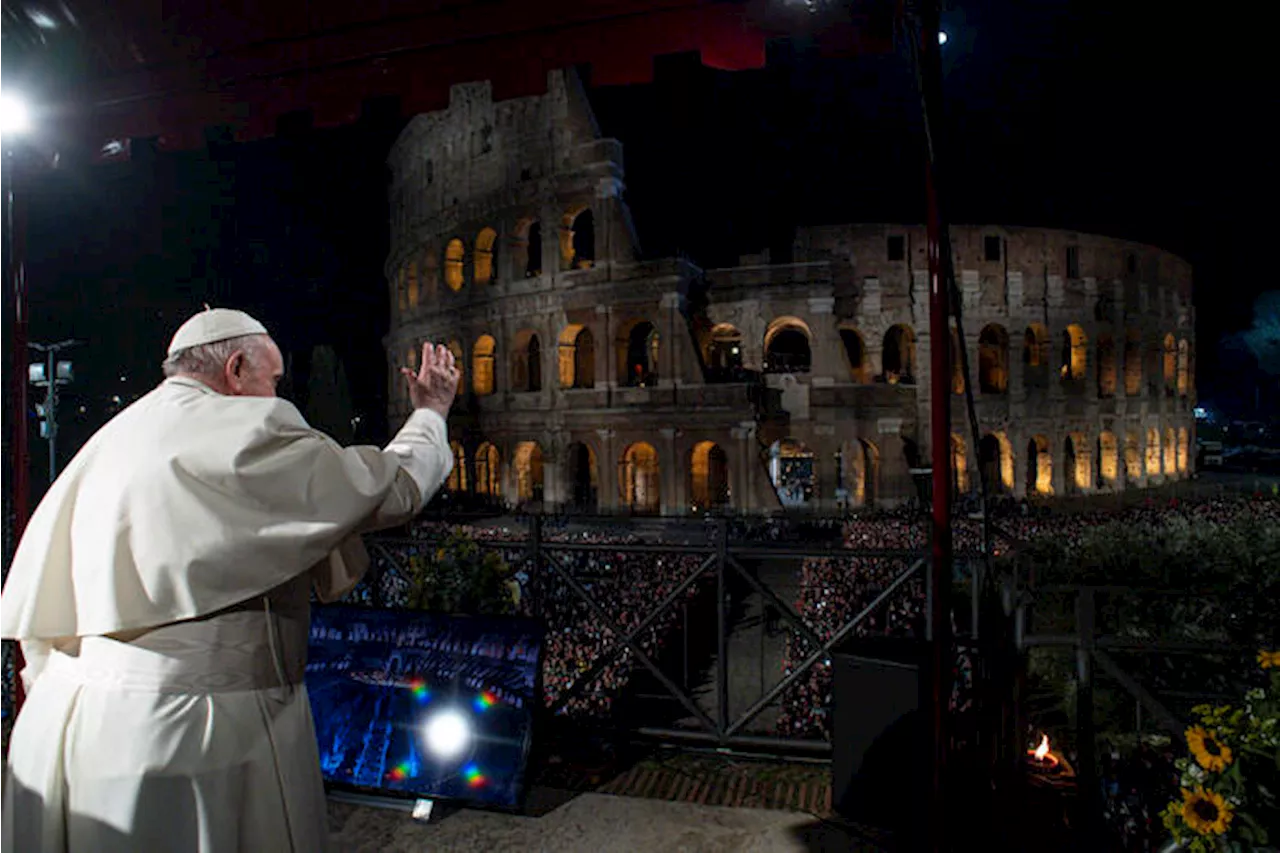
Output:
306 606 543 808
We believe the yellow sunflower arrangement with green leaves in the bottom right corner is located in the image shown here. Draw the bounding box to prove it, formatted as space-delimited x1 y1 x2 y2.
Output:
1161 651 1280 853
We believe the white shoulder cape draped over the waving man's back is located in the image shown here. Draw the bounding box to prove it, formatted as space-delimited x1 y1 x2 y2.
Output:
0 379 435 639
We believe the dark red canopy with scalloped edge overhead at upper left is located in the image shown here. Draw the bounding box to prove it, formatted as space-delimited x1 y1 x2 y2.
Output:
0 0 888 157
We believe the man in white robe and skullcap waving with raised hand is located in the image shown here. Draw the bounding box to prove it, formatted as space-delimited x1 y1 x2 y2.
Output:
0 309 458 853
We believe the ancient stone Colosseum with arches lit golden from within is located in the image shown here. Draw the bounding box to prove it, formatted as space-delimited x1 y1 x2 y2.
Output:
387 73 1196 515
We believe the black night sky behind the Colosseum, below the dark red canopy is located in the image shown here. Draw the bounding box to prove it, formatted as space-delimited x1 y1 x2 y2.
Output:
10 0 1276 471
